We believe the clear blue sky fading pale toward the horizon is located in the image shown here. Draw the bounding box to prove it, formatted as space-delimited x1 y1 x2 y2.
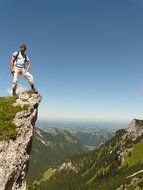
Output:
0 0 143 120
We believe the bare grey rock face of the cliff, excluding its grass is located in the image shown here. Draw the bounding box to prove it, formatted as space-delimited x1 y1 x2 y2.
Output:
0 92 41 190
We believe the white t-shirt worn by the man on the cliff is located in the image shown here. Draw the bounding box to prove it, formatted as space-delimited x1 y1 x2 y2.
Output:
13 51 29 68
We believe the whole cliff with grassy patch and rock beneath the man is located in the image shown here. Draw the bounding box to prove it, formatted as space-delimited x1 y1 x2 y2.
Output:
0 91 41 190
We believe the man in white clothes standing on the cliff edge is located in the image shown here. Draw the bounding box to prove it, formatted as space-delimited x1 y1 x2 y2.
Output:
10 44 38 96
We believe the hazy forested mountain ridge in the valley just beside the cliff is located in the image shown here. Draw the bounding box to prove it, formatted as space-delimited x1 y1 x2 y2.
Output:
27 128 88 186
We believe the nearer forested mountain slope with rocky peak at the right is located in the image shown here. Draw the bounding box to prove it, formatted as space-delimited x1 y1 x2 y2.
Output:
28 119 143 190
